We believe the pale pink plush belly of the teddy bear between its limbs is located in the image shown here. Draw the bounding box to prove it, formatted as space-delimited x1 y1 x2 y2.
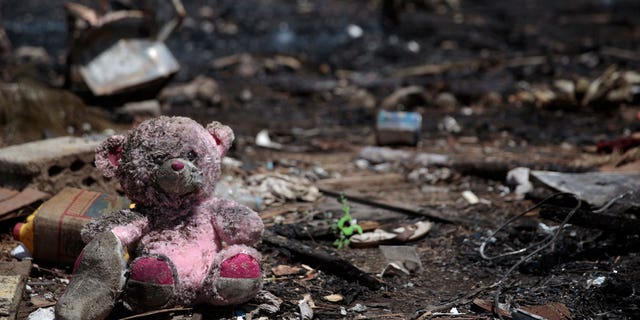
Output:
139 224 220 296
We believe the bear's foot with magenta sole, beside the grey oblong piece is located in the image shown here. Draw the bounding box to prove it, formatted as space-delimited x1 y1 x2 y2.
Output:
124 255 176 311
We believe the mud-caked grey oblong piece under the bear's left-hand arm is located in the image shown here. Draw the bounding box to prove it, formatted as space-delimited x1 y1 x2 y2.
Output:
55 231 126 319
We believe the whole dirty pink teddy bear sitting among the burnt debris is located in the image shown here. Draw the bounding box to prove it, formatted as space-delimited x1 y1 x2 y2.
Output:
56 116 264 319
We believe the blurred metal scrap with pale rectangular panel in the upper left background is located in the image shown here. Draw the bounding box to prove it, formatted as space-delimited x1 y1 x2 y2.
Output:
65 0 186 96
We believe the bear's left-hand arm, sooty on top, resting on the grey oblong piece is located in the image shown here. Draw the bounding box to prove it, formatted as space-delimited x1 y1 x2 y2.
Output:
80 209 149 246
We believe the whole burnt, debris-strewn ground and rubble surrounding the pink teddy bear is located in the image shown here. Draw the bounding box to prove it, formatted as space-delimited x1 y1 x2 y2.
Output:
0 0 640 320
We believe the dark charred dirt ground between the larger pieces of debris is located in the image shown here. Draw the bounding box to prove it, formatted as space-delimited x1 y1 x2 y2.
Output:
0 0 640 319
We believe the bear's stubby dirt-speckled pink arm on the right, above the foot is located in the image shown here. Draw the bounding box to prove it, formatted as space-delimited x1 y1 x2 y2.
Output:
212 199 264 246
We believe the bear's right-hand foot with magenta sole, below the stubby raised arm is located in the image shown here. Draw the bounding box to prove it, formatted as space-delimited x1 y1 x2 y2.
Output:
202 245 262 305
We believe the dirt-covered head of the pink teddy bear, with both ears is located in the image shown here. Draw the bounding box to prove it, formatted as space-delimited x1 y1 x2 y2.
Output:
95 116 234 209
